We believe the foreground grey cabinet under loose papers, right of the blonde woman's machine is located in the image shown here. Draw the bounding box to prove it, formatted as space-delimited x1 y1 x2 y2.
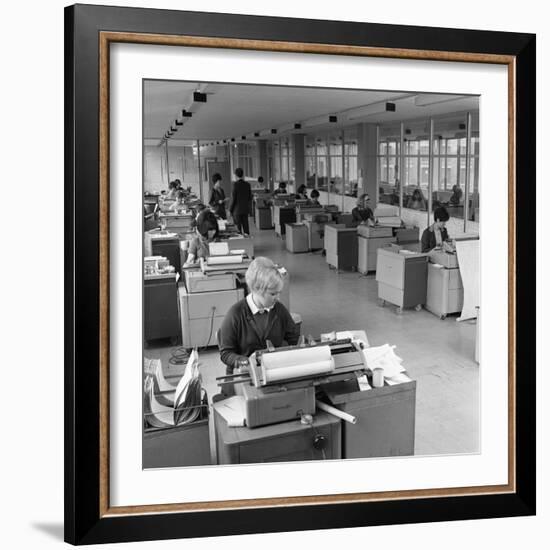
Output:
323 379 416 458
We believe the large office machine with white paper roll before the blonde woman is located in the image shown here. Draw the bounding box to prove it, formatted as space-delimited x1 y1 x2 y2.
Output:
217 338 368 428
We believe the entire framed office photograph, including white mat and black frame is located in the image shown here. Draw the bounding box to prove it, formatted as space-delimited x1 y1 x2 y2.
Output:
54 5 538 547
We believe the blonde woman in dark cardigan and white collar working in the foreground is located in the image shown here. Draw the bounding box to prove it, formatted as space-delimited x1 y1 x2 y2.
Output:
218 257 300 374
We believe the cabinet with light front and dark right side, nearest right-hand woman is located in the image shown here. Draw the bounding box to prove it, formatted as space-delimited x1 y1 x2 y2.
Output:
376 248 428 313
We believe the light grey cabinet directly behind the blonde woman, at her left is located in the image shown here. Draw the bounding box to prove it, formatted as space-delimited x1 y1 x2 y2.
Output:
178 285 244 348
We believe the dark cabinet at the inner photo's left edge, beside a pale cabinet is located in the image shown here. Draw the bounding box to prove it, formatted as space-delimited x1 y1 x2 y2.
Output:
143 273 180 343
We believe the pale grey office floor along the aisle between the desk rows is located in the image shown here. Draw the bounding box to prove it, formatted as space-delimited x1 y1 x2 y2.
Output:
145 218 479 464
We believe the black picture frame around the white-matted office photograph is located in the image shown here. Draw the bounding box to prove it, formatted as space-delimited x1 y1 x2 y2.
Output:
65 5 536 544
